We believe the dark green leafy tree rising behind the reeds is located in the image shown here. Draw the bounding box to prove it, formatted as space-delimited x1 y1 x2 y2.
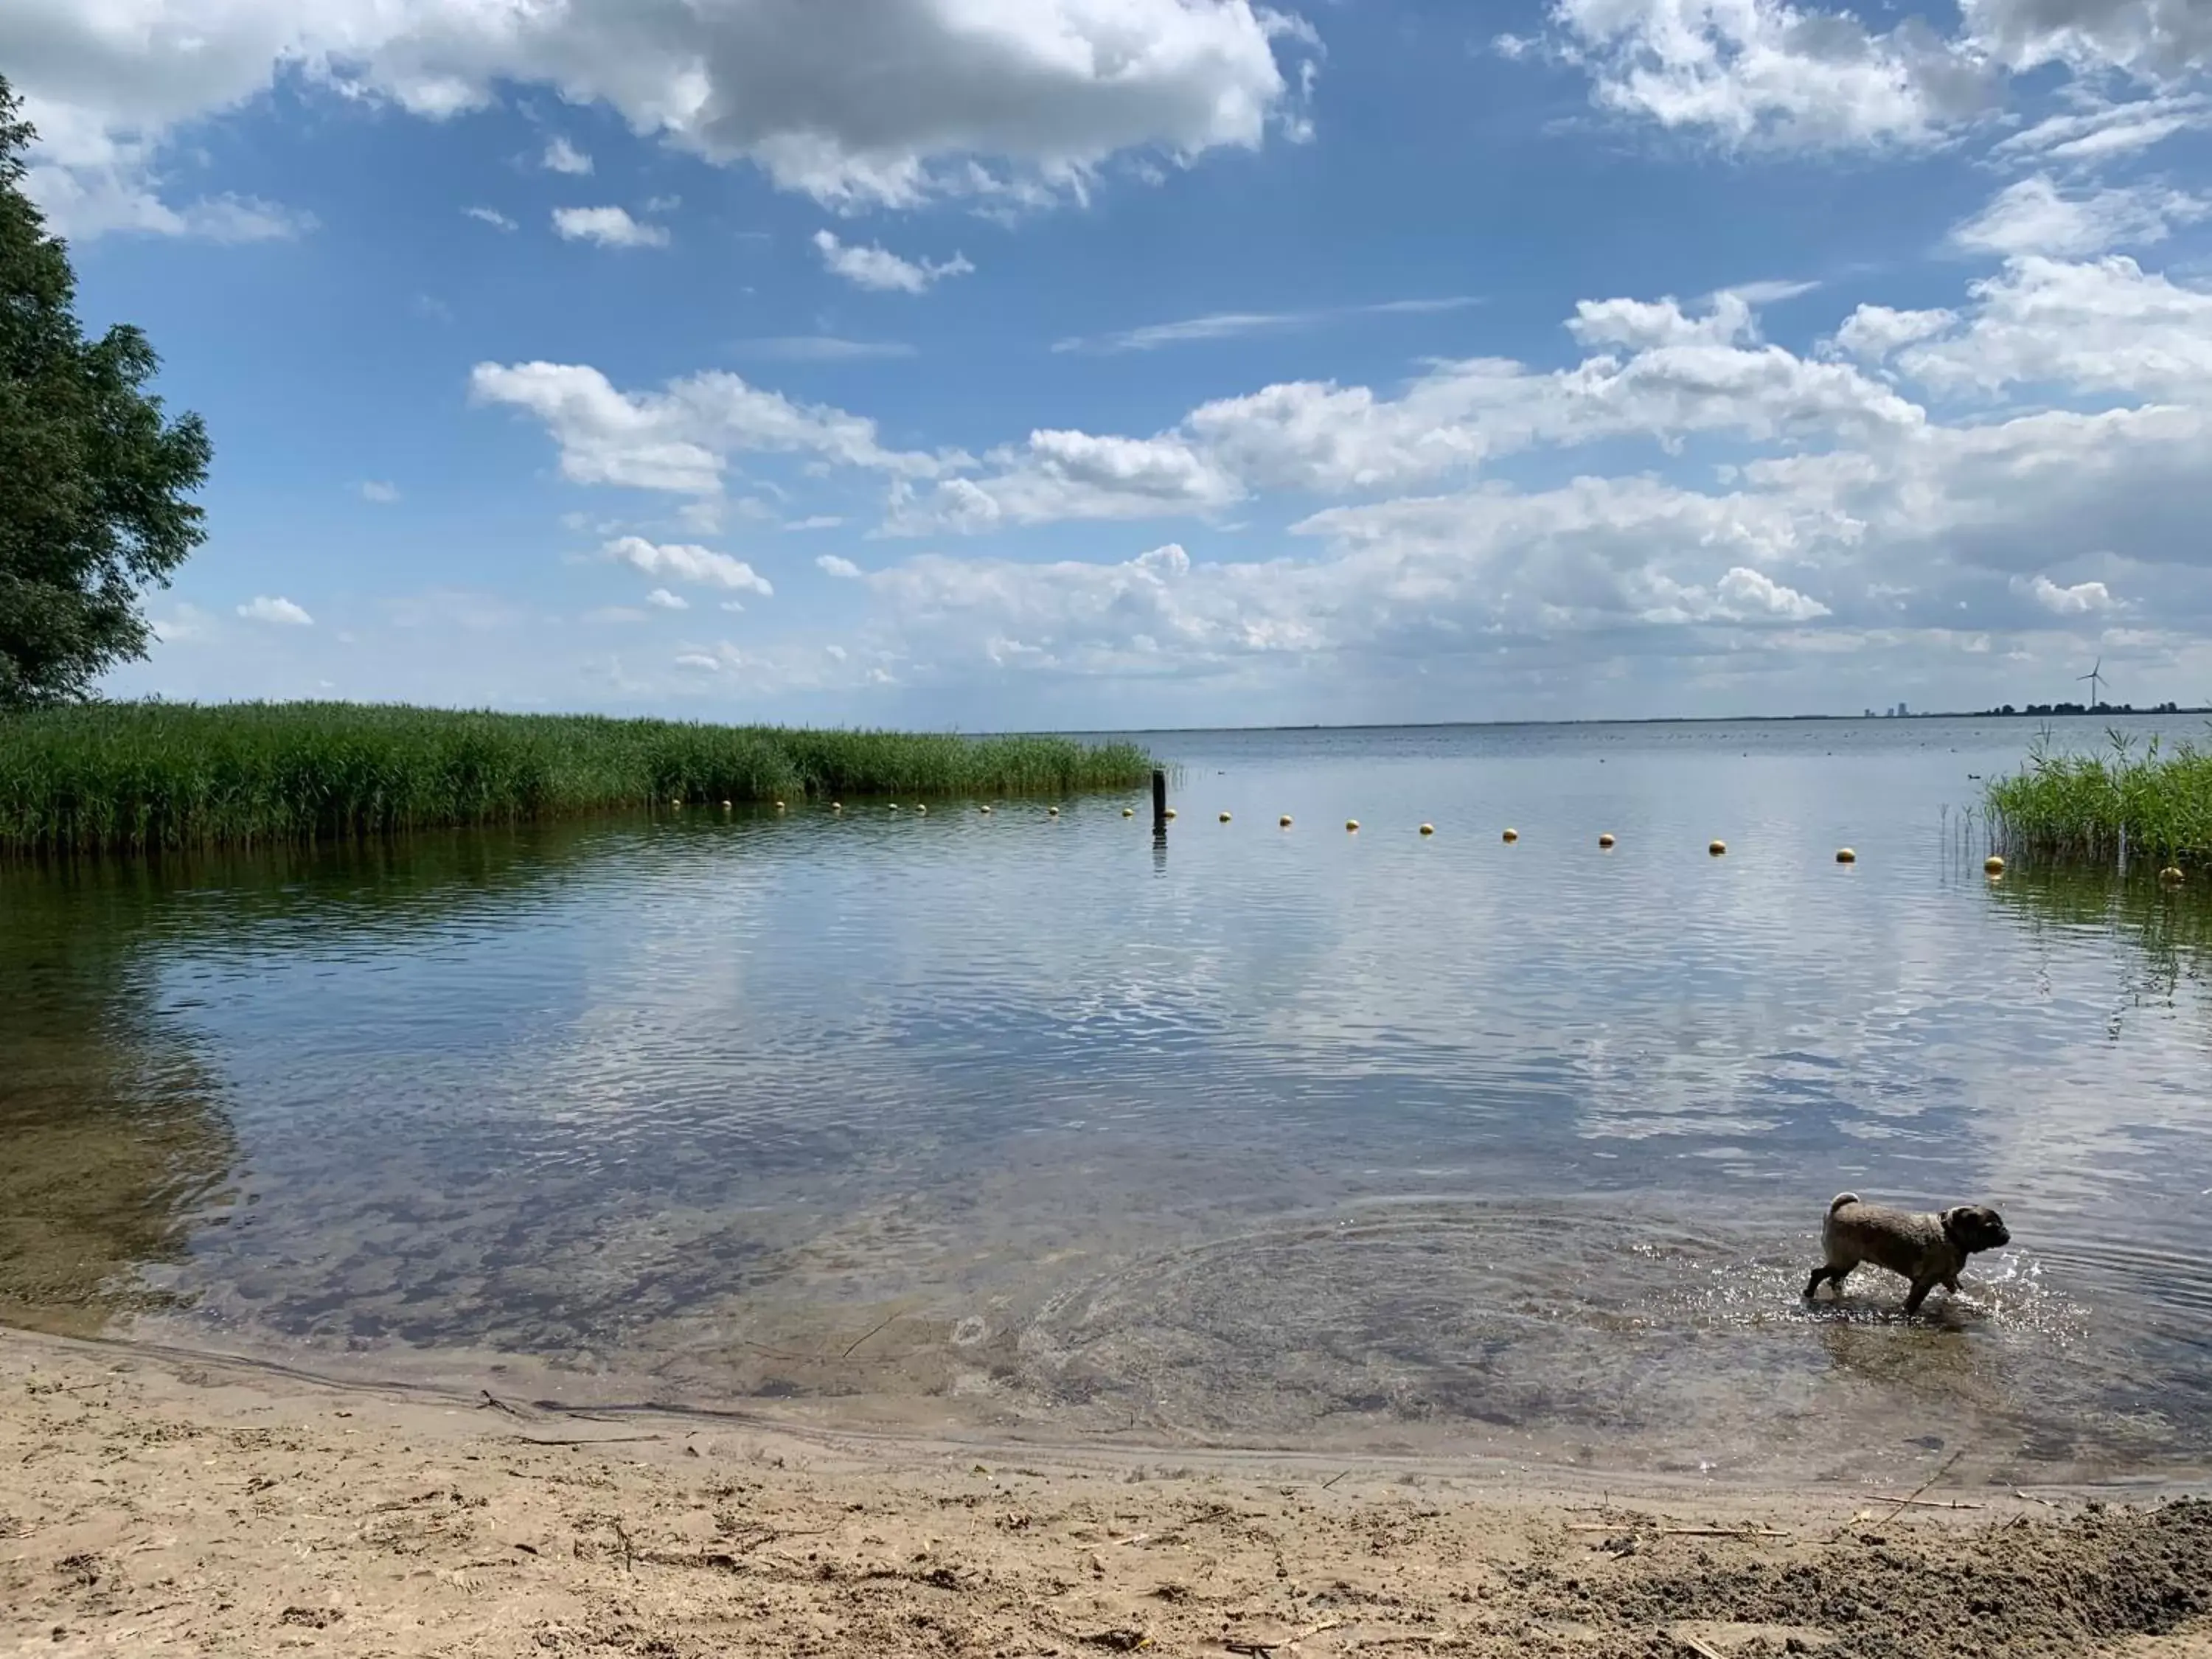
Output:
0 77 210 708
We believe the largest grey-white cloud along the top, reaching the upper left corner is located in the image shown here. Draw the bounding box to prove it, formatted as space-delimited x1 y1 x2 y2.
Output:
0 0 1314 234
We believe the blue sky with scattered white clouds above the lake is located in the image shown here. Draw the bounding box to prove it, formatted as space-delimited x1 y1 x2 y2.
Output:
0 0 2212 728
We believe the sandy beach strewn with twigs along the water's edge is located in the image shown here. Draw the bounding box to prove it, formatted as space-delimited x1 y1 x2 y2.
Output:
0 1332 2212 1659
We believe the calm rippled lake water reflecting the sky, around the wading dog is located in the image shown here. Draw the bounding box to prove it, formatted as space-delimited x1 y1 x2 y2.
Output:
0 721 2212 1482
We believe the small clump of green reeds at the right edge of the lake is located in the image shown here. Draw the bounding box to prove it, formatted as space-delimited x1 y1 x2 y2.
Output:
1989 732 2212 863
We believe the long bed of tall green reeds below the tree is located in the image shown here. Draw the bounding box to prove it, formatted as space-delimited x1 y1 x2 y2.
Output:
0 703 1152 854
